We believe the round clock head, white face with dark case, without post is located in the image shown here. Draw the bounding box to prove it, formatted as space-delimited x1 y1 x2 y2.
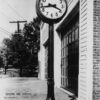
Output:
36 0 67 23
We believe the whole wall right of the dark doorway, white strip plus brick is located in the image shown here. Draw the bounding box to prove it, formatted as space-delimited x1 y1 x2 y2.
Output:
79 0 100 100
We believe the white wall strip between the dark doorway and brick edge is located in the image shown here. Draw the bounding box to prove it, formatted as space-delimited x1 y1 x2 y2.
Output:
78 0 94 100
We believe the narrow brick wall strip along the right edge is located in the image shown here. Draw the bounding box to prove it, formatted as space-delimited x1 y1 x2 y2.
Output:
93 0 100 100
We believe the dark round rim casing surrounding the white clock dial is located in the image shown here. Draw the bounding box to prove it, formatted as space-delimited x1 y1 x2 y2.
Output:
36 0 68 23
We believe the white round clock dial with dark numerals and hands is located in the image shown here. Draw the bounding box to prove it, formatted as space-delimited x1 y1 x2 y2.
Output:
38 0 67 23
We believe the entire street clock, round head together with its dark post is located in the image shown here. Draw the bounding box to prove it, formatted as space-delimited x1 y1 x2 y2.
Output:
36 0 67 100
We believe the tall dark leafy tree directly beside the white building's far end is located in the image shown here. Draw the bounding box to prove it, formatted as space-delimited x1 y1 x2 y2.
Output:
23 17 41 76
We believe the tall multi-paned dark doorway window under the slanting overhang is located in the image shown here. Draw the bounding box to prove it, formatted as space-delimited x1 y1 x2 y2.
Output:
61 14 79 92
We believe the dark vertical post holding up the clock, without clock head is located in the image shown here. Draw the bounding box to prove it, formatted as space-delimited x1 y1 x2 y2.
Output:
46 23 55 100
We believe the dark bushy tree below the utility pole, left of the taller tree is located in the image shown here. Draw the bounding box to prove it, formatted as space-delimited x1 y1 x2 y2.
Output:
4 34 27 75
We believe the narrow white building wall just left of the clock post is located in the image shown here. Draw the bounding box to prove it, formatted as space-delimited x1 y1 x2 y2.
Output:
38 23 48 80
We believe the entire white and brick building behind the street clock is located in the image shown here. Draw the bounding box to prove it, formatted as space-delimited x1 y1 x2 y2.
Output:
39 0 100 100
